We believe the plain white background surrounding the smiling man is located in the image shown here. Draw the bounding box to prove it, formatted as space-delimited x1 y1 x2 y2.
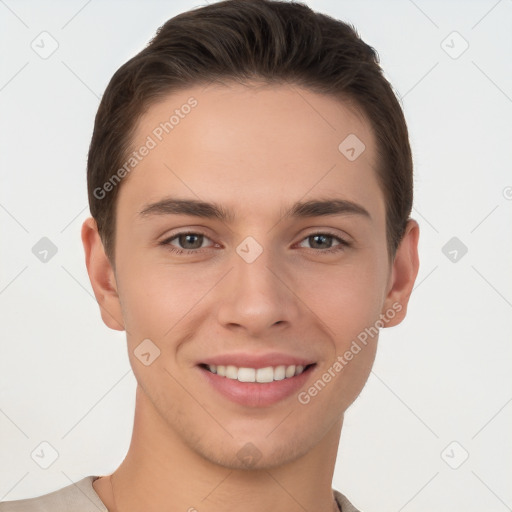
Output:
0 0 512 512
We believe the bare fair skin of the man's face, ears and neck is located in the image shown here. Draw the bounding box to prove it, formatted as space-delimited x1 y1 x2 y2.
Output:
82 83 419 512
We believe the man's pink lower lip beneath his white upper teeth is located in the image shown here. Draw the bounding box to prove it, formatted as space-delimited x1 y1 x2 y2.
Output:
199 365 315 407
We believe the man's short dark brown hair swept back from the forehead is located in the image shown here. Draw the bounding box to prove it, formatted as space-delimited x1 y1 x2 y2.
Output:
87 0 413 265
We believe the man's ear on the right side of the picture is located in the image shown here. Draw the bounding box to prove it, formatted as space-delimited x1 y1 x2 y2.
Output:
381 219 420 327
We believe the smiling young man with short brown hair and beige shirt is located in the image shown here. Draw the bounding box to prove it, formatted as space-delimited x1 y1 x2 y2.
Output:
0 0 419 512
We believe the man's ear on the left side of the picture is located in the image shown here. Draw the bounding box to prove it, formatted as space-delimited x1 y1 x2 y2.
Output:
82 217 124 331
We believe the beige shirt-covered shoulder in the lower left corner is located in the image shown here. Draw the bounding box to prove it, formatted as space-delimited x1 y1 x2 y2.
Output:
0 476 108 512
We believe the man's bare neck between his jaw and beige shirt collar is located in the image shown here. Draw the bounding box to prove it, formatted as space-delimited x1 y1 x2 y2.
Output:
95 387 342 512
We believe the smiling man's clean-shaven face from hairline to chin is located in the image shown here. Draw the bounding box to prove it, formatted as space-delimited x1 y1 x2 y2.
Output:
84 84 412 468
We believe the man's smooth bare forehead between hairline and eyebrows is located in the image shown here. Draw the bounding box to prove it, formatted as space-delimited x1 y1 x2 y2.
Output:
118 80 384 224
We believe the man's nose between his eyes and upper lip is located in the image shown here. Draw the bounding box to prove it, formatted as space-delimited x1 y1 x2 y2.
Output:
217 243 300 337
